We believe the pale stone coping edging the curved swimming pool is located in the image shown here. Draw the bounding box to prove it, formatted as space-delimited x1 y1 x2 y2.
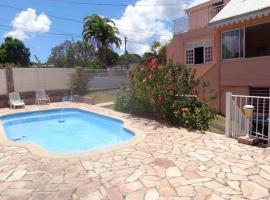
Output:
0 103 145 158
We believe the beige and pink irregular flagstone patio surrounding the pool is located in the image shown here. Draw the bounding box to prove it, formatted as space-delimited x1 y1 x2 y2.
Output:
0 104 270 200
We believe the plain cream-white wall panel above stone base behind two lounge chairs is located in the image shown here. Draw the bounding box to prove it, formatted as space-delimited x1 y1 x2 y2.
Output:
13 68 76 92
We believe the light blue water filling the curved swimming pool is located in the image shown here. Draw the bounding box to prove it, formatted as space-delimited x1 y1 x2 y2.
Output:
0 108 134 153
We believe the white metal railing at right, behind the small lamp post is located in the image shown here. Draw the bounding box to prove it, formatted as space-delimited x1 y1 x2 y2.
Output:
225 93 270 143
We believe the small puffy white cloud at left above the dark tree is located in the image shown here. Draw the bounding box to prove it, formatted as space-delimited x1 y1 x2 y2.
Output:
4 8 52 40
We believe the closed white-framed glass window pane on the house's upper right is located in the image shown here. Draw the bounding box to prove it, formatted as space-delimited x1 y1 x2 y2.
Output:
222 29 244 59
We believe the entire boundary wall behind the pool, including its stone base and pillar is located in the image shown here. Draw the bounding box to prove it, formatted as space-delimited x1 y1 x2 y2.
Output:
0 67 129 107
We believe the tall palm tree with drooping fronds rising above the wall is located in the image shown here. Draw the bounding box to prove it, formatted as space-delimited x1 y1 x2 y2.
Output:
83 14 121 65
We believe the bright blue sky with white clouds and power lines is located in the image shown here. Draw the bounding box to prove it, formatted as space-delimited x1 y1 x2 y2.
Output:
0 0 193 62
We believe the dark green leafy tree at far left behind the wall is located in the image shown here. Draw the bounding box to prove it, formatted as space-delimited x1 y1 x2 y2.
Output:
0 37 30 66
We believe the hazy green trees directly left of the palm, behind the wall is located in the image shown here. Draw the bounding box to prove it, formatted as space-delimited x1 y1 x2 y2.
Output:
47 40 96 68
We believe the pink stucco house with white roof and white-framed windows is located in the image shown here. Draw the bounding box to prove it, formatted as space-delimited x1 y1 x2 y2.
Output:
167 0 270 114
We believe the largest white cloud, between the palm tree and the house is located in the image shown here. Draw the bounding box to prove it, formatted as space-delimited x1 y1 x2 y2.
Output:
114 0 190 54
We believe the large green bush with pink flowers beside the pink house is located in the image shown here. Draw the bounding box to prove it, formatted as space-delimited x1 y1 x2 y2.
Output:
116 59 215 130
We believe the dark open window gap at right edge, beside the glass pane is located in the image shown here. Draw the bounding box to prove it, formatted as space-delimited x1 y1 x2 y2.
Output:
245 23 270 58
